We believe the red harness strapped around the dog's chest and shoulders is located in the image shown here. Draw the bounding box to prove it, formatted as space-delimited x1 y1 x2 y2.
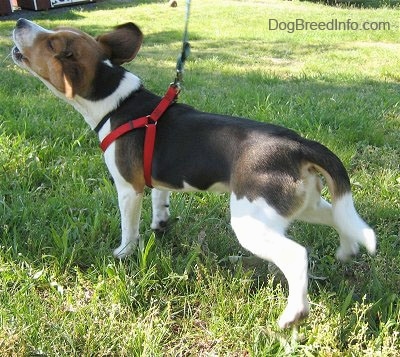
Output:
100 84 179 187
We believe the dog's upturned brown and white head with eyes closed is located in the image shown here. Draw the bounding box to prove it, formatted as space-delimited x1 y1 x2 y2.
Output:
12 19 143 99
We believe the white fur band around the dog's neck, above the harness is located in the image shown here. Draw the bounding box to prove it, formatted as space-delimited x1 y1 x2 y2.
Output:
64 72 141 129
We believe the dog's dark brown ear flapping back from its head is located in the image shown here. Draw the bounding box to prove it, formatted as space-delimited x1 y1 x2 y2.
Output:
97 22 143 65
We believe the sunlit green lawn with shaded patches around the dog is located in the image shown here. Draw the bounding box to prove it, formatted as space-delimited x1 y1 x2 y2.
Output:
0 0 400 356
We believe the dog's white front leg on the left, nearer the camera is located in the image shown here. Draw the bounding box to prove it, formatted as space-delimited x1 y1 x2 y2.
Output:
114 183 143 259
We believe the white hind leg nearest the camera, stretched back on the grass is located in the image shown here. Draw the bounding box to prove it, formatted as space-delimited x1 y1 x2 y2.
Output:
231 193 309 328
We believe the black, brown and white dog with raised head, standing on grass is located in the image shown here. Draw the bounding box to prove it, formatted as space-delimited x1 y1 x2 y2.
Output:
12 19 376 328
